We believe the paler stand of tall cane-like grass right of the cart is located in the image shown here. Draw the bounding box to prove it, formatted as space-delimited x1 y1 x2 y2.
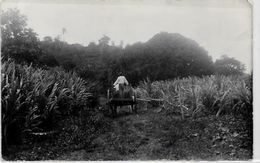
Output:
136 75 252 118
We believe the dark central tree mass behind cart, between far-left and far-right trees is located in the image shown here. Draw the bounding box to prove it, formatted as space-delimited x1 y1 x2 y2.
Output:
37 32 214 90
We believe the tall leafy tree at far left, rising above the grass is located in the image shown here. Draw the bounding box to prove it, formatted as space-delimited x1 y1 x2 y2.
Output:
1 9 41 63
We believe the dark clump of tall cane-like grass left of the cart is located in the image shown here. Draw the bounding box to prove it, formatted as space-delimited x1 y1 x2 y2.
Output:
1 61 91 144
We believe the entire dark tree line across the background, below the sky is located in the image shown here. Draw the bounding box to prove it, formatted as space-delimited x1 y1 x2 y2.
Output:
1 9 245 91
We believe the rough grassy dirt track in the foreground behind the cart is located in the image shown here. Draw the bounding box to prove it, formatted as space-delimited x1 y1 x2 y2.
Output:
58 105 251 160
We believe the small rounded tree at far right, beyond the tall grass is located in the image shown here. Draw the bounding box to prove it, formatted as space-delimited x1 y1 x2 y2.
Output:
215 55 245 75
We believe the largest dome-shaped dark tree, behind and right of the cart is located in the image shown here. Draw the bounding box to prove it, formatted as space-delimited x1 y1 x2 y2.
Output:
123 32 214 84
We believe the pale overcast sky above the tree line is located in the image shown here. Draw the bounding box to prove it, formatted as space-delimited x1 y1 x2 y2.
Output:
2 0 252 72
